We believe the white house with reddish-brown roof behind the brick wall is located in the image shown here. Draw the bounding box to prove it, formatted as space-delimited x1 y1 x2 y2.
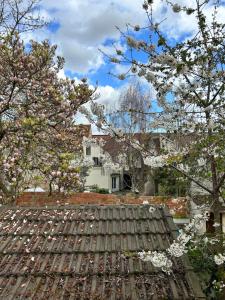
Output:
84 132 199 195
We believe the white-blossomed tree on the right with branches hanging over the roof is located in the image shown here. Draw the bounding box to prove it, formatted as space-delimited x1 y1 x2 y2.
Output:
88 0 225 294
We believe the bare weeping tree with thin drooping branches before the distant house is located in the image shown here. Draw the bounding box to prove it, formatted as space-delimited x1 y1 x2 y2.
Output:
105 81 151 191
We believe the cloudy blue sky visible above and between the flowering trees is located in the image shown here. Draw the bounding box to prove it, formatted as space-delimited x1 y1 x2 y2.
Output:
31 0 225 130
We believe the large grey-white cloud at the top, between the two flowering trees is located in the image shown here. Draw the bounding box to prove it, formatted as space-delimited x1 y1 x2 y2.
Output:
37 0 144 73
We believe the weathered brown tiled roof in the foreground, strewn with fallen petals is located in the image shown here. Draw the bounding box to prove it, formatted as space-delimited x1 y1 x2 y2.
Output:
0 205 204 300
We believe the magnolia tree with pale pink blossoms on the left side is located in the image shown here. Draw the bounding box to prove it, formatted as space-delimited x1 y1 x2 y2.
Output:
0 0 94 199
